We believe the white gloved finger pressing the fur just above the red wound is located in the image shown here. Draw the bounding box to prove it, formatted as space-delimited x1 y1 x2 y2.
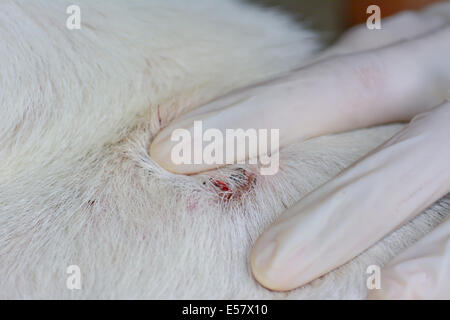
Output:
150 25 450 174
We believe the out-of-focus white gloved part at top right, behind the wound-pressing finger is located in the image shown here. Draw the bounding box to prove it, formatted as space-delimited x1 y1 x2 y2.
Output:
313 2 450 61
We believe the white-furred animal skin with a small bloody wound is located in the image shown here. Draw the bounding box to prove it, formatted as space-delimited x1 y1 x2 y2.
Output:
0 0 450 299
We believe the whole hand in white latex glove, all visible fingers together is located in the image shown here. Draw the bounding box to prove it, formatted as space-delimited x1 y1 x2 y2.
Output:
150 3 450 298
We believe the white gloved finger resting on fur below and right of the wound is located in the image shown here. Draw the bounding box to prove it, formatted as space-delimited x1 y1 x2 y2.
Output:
251 102 450 291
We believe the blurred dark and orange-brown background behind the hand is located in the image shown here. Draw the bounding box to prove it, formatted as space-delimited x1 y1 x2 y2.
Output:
249 0 446 42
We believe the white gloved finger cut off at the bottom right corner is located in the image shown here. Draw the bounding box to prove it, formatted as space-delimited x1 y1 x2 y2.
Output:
368 216 450 300
